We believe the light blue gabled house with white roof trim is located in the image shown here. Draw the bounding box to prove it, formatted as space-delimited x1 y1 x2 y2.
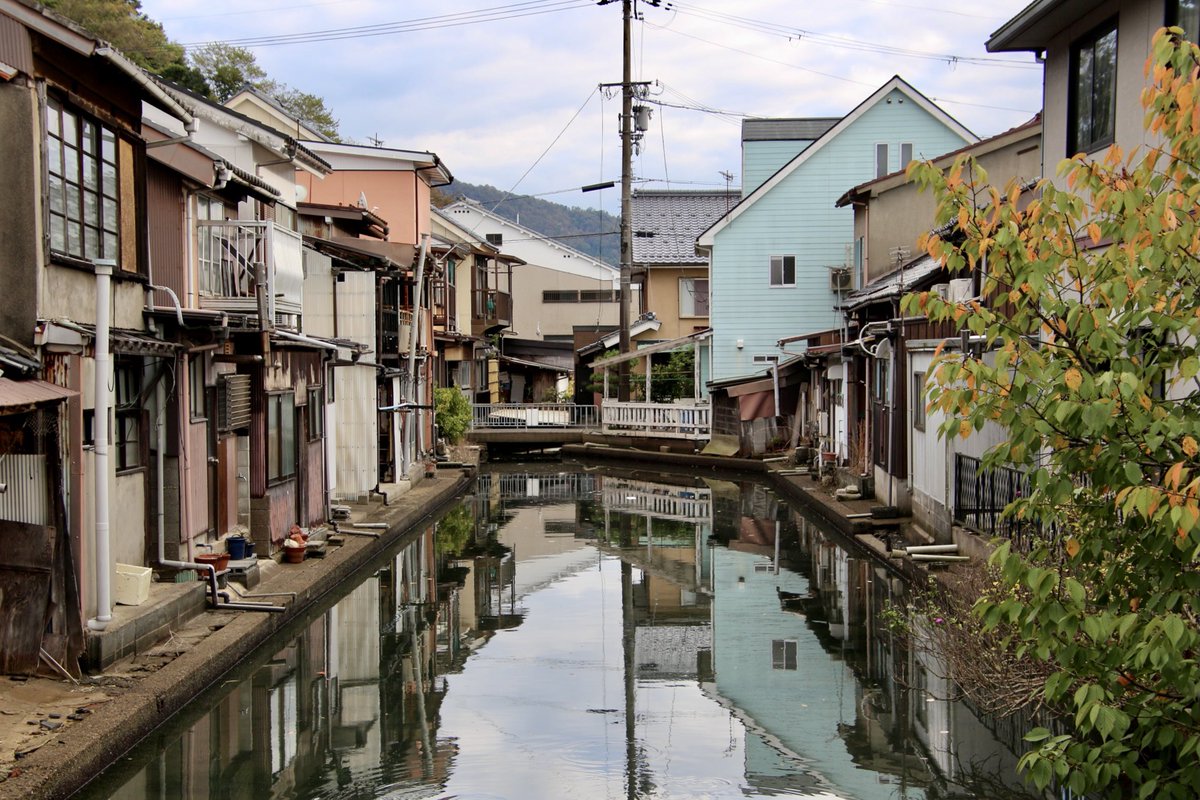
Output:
697 77 976 380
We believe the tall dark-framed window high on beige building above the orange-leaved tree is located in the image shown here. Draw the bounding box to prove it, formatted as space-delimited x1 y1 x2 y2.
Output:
1067 19 1117 155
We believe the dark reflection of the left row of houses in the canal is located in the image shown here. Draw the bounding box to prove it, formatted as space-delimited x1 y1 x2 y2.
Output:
111 528 457 799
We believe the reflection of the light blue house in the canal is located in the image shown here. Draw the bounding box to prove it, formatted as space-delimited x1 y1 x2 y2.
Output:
713 548 902 798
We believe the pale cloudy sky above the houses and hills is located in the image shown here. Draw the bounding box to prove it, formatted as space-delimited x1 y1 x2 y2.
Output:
142 0 1042 210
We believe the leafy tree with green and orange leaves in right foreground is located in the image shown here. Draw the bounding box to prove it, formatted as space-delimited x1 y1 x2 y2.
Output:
904 29 1200 798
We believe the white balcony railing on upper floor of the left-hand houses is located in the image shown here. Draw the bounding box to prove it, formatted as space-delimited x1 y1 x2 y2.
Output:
196 219 304 324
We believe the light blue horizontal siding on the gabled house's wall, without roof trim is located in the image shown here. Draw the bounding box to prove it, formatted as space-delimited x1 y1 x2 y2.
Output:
710 90 964 380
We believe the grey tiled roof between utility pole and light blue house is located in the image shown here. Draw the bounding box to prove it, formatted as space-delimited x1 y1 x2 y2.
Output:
630 190 742 266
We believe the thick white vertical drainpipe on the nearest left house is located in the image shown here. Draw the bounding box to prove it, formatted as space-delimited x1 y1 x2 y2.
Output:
88 259 116 631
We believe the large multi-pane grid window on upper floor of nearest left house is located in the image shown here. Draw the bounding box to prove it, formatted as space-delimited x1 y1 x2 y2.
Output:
46 97 121 260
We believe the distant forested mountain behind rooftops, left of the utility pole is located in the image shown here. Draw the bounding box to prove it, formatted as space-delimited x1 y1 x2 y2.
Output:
433 181 620 265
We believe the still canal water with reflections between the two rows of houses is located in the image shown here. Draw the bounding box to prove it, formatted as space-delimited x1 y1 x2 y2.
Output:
82 464 1033 800
